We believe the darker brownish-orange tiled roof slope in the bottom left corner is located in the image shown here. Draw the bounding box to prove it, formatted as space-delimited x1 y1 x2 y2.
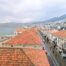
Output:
0 48 33 66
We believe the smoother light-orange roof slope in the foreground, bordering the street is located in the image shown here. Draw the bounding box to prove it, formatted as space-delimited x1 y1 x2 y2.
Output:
24 49 50 66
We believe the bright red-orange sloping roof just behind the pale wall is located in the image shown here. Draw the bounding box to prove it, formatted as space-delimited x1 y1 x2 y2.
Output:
6 28 41 45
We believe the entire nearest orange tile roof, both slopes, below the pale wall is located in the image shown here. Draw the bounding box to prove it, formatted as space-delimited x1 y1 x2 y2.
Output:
0 48 50 66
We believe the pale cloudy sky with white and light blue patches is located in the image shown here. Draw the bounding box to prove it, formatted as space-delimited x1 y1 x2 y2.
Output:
0 0 66 23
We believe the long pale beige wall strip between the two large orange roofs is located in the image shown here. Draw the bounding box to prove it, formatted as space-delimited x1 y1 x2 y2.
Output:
0 44 42 49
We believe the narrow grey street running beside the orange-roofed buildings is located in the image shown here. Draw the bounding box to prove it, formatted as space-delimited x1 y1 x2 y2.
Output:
40 30 60 66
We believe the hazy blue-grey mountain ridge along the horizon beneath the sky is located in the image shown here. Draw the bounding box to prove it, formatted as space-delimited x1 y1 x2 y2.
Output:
0 14 66 28
